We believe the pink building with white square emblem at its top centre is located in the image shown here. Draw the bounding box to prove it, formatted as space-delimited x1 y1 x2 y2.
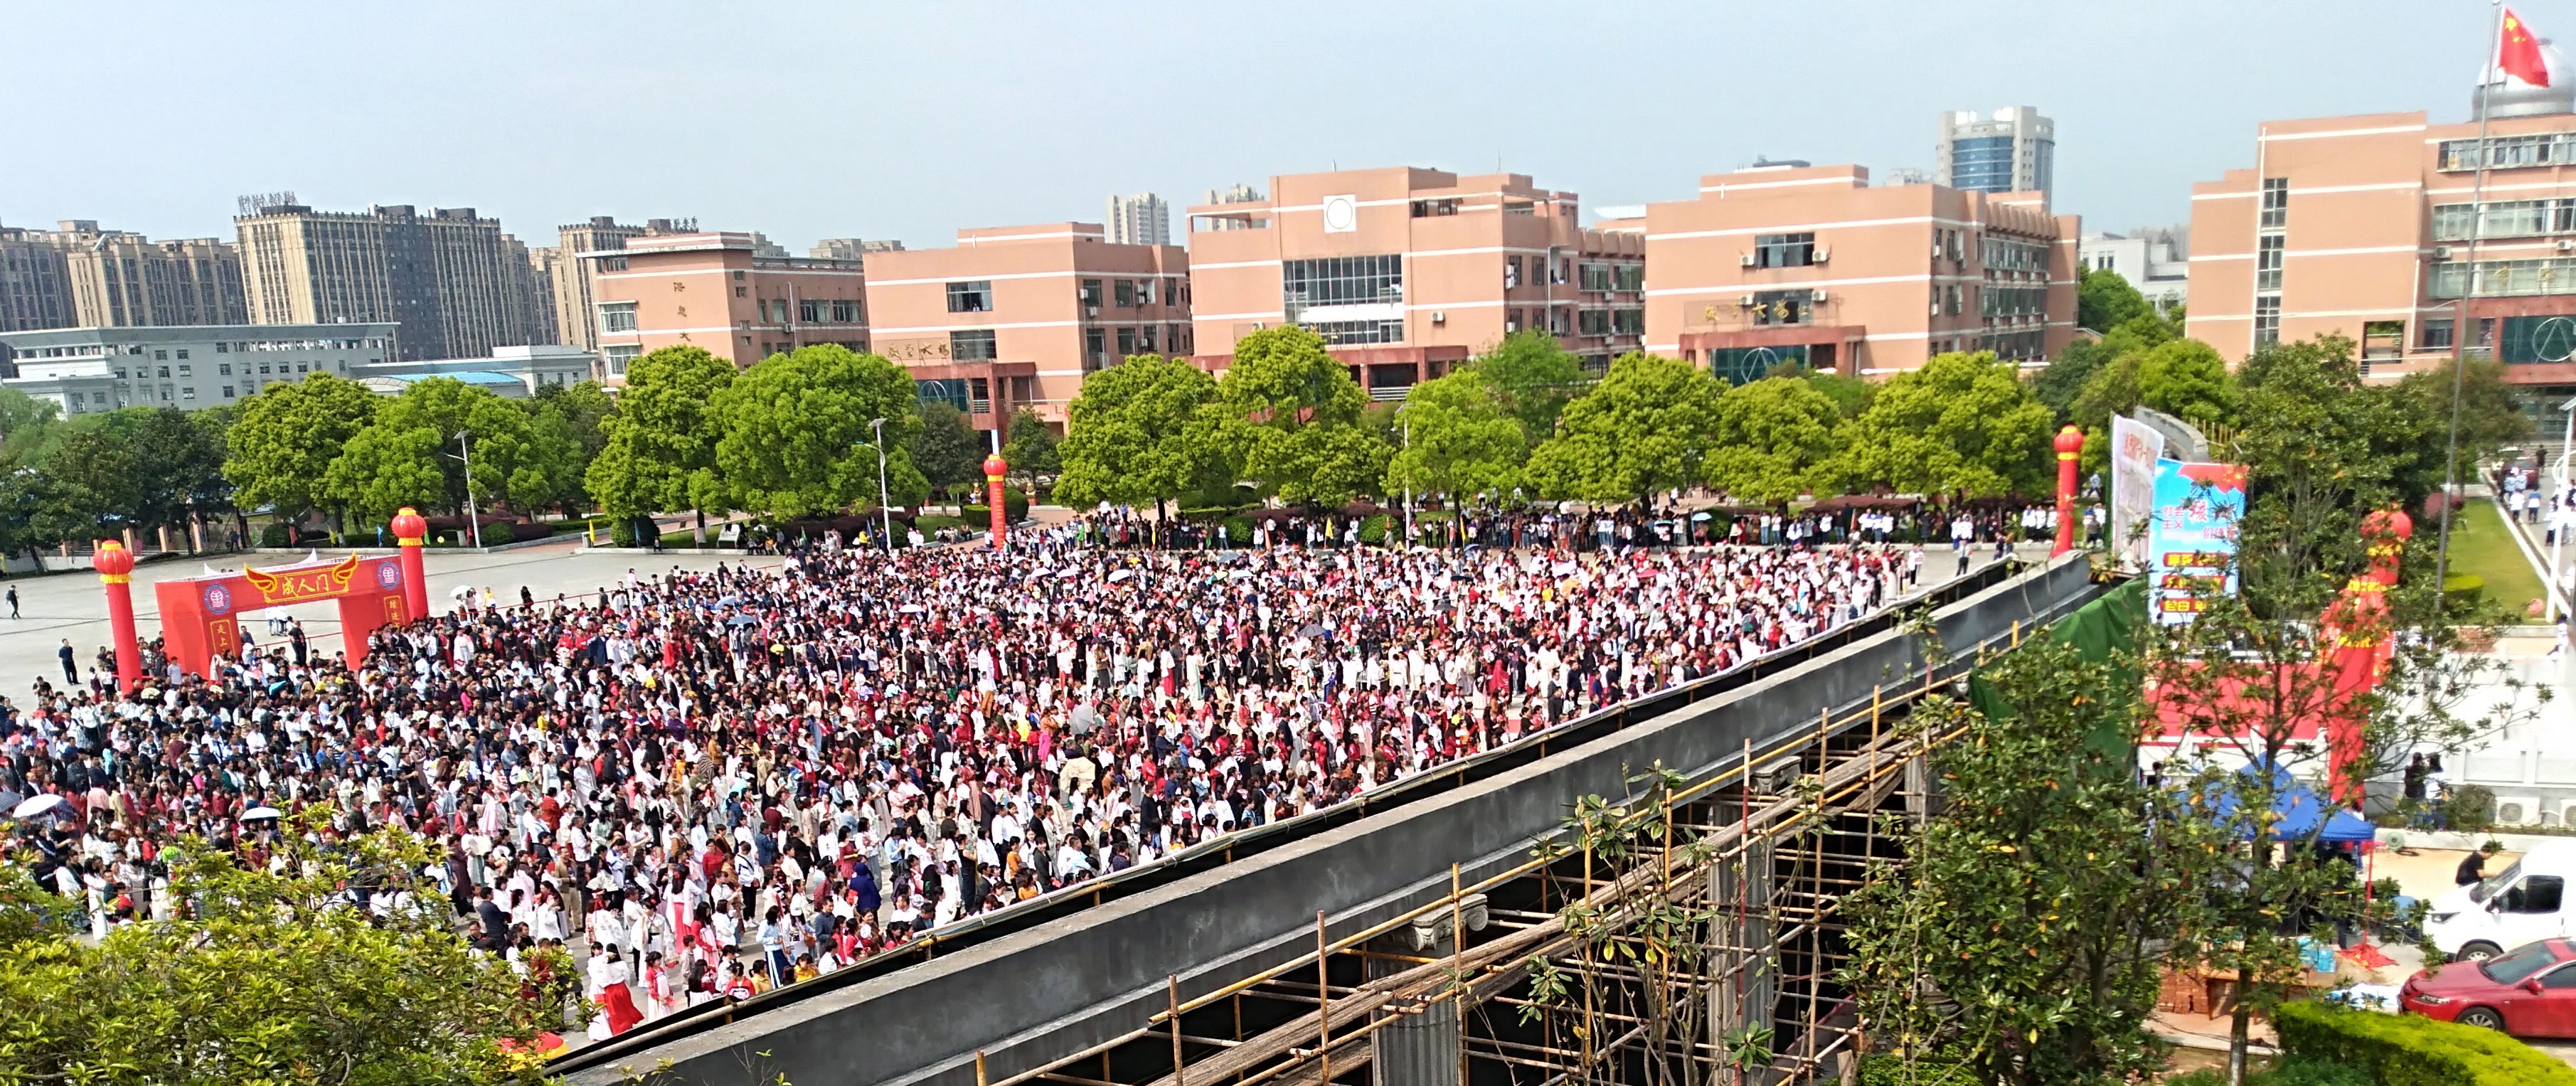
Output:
1190 167 1646 399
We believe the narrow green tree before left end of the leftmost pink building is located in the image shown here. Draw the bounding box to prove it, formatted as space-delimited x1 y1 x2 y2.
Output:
585 347 737 543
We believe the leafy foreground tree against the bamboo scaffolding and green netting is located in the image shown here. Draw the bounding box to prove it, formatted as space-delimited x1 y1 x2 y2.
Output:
1842 638 2210 1086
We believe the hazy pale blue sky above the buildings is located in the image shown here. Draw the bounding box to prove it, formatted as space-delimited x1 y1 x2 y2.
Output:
0 0 2535 252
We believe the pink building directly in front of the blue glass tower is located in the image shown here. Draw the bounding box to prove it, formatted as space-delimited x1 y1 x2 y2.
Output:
1646 165 2082 383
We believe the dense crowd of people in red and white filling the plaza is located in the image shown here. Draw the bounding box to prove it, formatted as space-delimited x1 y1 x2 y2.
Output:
0 517 1925 1032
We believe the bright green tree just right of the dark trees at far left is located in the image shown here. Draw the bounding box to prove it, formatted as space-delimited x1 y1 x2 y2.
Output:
224 373 378 517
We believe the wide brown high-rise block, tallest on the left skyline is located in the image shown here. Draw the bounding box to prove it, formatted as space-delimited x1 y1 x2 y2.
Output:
235 193 548 358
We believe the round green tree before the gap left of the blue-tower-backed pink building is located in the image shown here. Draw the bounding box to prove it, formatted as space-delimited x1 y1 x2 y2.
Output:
1525 353 1720 502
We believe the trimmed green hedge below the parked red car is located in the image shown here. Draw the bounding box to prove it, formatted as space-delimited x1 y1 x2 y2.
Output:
2272 1004 2576 1086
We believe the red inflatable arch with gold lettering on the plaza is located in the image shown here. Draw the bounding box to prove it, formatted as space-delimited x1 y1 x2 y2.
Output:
152 553 420 677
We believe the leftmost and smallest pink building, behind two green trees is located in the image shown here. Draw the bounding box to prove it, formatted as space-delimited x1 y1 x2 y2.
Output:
590 232 868 383
